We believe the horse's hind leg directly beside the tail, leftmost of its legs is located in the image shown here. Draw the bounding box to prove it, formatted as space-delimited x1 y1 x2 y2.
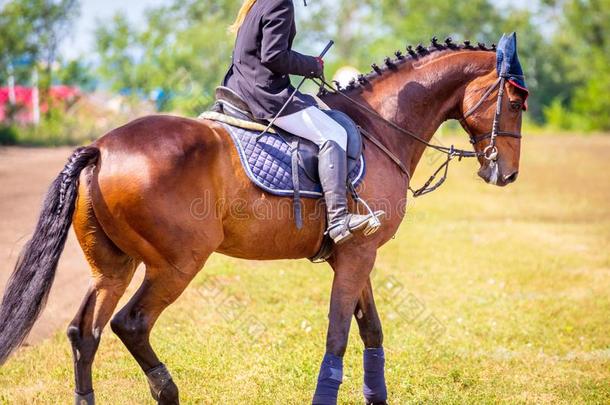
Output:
68 181 137 405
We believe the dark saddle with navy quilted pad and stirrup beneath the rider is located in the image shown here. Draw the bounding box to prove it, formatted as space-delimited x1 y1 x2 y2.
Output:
199 87 366 263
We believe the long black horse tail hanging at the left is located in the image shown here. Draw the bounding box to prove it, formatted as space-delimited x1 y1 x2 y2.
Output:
0 146 100 365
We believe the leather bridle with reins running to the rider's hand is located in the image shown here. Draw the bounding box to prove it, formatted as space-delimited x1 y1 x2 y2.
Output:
311 75 521 197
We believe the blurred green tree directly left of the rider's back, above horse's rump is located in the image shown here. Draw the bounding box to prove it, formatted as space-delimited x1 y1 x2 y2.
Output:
97 0 241 114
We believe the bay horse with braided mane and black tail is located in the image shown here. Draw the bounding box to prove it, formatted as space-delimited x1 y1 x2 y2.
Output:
0 38 527 404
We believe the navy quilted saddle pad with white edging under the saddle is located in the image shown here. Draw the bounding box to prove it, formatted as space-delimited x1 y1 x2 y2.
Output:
222 124 366 198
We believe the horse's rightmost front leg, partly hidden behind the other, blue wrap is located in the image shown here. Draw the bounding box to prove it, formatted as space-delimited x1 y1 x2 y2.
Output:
354 278 388 405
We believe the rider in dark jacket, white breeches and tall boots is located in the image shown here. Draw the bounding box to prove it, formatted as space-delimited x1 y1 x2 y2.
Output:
224 0 382 244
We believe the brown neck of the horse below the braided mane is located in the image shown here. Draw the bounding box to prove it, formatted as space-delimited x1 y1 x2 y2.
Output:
328 52 492 173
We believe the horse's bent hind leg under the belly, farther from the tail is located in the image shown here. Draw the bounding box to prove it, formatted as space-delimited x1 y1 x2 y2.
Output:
111 258 211 404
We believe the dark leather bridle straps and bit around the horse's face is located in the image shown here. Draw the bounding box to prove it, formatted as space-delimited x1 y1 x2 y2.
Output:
460 76 521 161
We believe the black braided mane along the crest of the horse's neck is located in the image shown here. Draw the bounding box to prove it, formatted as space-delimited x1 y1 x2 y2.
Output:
318 37 496 96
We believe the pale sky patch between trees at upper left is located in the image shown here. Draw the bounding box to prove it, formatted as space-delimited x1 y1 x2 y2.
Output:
62 0 169 59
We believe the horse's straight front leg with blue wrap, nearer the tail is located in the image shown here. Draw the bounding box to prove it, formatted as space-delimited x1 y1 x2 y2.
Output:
313 248 376 405
